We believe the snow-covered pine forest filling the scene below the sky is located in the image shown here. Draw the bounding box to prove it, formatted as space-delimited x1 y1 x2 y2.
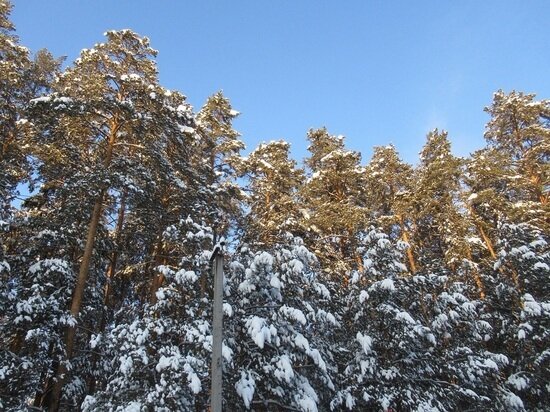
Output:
0 0 550 412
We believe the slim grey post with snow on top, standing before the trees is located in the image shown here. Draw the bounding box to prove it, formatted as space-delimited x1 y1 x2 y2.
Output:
210 242 225 412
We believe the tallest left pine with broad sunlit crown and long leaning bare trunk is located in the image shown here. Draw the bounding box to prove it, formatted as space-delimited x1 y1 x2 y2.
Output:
27 30 198 409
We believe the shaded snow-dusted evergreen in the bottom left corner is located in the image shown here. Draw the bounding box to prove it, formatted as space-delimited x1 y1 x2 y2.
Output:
0 219 77 411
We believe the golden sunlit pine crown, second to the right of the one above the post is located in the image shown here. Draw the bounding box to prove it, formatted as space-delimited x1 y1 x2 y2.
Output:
300 128 365 280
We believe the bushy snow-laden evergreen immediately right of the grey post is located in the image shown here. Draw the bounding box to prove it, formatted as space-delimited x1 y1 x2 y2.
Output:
225 235 338 412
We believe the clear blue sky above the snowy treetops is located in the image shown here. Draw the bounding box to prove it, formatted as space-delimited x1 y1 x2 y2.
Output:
12 0 550 163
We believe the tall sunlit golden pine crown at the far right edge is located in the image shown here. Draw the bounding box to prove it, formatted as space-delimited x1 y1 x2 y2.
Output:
464 90 550 294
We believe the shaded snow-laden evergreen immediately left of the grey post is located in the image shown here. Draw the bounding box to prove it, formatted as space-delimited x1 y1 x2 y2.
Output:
82 217 216 411
